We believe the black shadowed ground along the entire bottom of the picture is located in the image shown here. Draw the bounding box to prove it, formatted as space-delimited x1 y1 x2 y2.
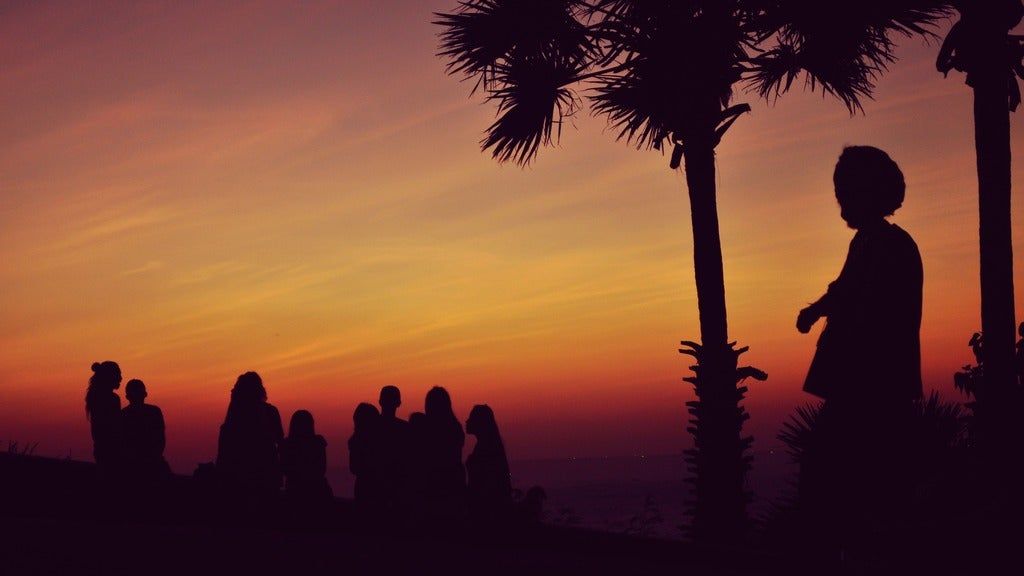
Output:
0 454 1024 576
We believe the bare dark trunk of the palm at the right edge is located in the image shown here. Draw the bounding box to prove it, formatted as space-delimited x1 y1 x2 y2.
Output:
971 72 1017 431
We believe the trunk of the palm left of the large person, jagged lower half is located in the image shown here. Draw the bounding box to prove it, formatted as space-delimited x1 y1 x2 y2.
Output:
684 138 751 545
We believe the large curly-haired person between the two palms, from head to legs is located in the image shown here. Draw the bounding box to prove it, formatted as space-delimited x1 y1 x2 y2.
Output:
797 147 924 517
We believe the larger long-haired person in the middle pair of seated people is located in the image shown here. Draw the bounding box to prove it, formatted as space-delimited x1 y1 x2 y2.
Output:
217 372 285 492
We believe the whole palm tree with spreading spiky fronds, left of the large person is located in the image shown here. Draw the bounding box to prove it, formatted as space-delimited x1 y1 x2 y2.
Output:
435 0 939 543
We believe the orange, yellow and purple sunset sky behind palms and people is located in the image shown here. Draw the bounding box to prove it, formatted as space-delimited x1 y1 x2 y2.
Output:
0 0 1024 471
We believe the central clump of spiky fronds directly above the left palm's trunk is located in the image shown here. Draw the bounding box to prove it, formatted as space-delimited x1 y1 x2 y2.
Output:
593 0 749 149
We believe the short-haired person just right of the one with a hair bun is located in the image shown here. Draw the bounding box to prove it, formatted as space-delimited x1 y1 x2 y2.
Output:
121 379 170 480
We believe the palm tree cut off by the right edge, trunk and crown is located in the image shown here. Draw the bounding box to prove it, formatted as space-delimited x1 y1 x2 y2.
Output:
937 0 1024 452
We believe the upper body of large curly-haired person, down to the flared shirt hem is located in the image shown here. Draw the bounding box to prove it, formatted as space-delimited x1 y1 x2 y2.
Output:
797 147 923 409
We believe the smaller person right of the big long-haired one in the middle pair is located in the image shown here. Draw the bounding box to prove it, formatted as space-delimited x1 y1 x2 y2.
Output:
281 410 333 502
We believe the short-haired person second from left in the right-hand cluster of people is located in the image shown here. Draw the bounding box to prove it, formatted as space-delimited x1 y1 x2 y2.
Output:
378 386 411 505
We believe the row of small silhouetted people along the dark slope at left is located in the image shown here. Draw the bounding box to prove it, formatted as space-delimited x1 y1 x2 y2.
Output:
86 361 524 522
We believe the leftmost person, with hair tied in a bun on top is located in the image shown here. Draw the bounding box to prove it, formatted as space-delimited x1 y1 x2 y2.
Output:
85 360 124 474
